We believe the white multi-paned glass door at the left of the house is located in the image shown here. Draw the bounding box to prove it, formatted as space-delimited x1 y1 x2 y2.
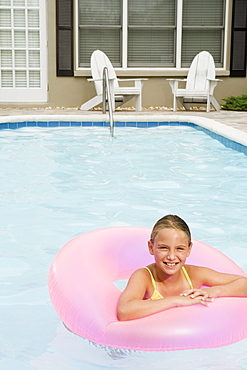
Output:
0 0 47 102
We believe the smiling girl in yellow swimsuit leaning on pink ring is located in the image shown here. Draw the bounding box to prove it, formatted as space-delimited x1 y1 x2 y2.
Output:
118 215 247 320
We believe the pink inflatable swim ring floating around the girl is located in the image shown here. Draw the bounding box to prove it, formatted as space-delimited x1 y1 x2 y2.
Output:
49 227 247 351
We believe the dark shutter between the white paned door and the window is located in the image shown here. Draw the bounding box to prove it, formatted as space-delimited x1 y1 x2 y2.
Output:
57 0 74 76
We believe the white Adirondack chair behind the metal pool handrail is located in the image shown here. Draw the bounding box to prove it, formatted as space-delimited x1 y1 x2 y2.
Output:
81 50 145 111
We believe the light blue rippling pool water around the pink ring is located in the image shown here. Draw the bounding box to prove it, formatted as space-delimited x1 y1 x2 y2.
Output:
0 126 247 370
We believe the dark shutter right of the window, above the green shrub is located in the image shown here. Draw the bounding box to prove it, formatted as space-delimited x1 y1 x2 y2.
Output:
230 0 247 77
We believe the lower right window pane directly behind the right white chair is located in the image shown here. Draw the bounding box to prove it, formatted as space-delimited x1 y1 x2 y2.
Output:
182 29 222 67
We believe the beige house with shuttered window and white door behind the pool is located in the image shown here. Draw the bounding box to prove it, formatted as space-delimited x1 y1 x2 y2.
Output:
0 0 247 107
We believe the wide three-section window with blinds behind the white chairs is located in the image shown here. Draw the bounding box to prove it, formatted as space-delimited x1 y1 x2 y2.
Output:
77 0 228 69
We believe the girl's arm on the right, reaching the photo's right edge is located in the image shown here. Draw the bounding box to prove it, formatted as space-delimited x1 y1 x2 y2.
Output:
180 266 247 299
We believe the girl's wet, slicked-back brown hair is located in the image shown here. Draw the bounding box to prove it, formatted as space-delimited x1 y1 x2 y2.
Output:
150 215 191 244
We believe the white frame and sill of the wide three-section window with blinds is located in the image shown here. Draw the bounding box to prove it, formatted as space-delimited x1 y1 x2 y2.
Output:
74 0 231 77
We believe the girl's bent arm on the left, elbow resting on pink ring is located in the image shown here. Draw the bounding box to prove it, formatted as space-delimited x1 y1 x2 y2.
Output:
117 269 207 321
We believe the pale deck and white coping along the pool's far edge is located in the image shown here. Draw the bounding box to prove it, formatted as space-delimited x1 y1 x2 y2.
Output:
0 107 247 147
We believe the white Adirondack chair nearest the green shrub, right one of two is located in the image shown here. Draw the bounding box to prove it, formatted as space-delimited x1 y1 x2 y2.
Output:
167 51 221 112
